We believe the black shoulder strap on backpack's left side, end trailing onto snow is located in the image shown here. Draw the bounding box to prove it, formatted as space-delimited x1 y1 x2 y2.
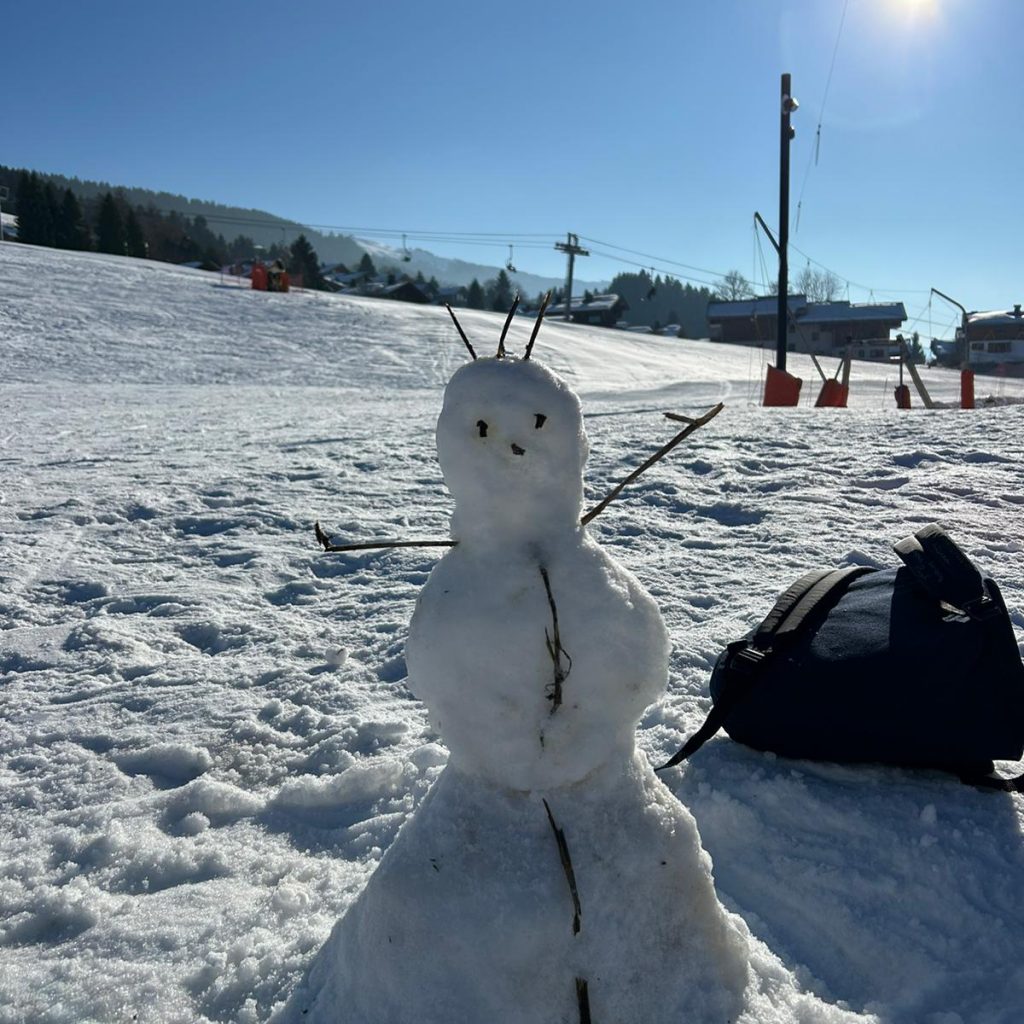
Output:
654 565 874 771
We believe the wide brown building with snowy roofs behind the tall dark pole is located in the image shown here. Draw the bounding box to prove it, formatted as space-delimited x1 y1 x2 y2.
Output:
708 295 906 360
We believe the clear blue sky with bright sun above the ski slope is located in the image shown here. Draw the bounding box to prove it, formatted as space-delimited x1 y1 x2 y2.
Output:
8 0 1024 331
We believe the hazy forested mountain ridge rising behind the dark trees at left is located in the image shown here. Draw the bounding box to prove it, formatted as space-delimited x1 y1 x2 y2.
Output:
0 167 607 296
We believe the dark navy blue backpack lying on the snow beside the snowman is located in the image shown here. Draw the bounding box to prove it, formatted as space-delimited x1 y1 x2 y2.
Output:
659 525 1024 792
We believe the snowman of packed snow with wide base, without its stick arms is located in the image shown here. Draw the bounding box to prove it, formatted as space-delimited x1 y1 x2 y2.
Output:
293 301 864 1024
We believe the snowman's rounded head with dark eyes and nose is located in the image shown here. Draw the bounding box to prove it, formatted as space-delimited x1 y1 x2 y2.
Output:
437 301 589 544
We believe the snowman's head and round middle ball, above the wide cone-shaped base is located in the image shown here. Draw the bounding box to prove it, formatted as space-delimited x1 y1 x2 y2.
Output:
407 357 669 791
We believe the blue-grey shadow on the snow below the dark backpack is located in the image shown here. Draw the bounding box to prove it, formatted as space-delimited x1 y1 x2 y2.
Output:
662 736 1024 1022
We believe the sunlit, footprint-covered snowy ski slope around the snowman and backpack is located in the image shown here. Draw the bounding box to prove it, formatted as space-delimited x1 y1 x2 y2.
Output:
0 245 1024 1024
